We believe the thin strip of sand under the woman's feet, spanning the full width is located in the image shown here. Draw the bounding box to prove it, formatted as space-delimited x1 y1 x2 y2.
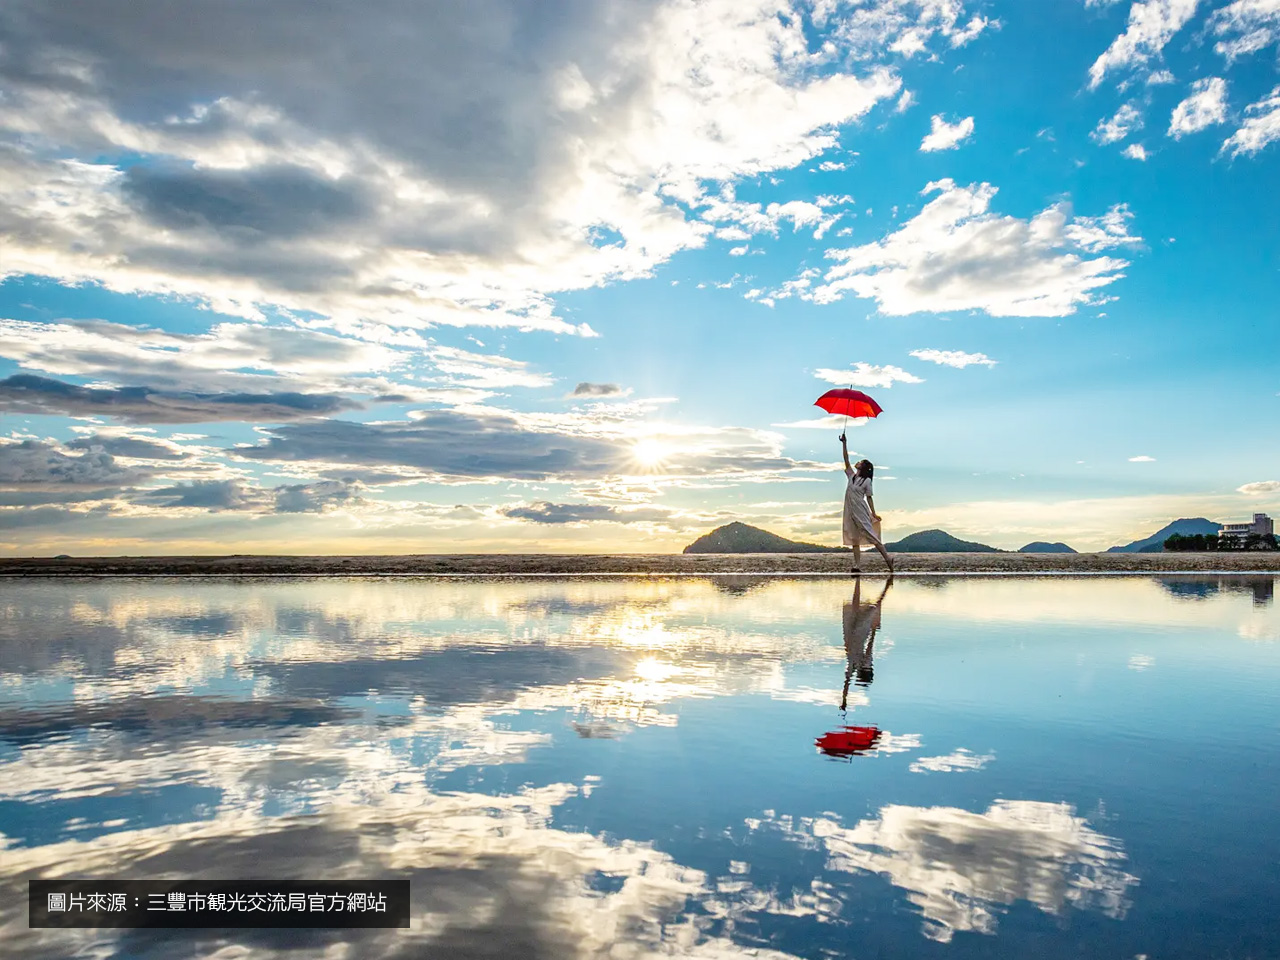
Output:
0 550 1280 576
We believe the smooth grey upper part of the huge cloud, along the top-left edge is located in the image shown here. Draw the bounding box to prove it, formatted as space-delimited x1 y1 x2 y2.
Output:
0 0 658 201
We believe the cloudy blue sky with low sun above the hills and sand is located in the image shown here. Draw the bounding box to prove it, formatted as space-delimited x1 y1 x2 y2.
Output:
0 0 1280 556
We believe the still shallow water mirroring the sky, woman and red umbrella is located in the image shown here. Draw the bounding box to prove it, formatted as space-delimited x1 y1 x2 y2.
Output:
0 576 1280 960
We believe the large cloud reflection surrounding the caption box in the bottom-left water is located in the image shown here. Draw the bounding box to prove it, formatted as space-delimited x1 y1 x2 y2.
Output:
0 783 788 959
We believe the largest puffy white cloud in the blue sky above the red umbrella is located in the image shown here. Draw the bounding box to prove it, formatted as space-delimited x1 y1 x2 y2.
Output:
806 179 1140 323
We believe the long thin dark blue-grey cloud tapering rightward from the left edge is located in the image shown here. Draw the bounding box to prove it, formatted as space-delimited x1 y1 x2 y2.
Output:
0 374 361 424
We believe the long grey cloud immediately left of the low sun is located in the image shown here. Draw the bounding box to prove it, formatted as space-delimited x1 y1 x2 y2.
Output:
233 410 622 480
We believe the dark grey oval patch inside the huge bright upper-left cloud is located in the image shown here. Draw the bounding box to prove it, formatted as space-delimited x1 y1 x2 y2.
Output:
123 165 369 241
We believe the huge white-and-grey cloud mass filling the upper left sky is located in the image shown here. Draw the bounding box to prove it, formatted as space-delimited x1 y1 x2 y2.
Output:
0 0 921 335
